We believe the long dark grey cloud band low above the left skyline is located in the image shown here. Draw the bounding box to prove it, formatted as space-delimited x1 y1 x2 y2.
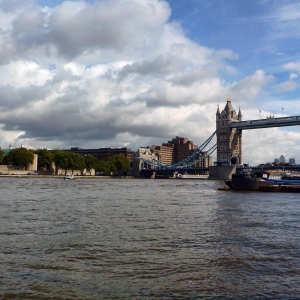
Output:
1 101 173 143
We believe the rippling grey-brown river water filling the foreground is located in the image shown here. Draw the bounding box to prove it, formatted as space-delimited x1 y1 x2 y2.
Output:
0 178 300 299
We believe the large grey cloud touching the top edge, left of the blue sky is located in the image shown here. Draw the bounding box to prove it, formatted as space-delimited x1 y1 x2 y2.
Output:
6 0 170 59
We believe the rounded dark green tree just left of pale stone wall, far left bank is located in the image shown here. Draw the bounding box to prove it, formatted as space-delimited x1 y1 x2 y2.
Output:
3 148 34 170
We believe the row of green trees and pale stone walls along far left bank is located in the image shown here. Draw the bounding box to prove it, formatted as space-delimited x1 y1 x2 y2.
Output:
0 148 131 176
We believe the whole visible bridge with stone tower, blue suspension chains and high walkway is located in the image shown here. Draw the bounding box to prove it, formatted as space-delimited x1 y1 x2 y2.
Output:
138 97 300 179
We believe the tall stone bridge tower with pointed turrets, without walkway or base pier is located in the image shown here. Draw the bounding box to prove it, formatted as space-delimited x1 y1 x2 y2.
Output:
216 97 242 166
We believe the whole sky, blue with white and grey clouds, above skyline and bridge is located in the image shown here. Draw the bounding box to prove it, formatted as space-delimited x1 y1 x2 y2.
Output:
0 0 300 164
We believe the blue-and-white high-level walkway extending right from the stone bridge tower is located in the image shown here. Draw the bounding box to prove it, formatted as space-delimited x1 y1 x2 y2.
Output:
230 116 300 130
